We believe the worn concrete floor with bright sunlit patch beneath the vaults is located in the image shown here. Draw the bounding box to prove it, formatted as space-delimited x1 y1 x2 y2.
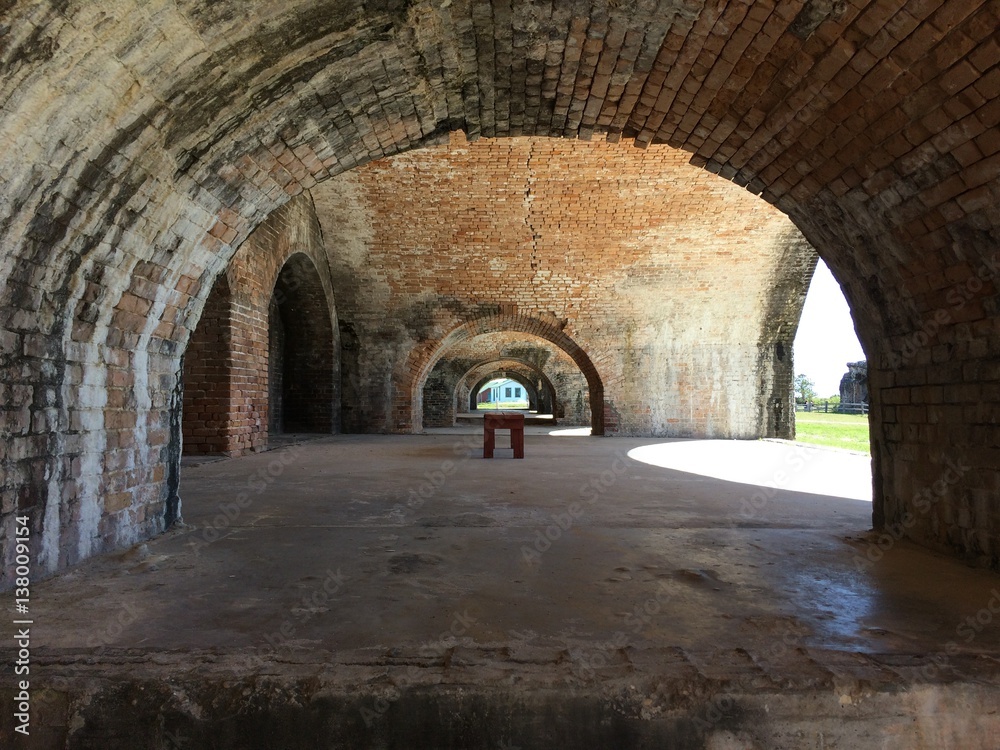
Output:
0 427 1000 748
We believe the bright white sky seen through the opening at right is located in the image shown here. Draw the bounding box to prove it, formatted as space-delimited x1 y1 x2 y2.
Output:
794 260 865 398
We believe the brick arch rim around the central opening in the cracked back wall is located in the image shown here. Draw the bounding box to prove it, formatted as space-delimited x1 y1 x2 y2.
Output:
404 311 604 435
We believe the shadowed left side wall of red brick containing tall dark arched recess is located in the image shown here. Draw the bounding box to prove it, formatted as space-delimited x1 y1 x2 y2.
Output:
183 196 340 456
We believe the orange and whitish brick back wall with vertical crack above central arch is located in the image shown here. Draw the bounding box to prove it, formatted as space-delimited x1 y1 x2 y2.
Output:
315 136 815 437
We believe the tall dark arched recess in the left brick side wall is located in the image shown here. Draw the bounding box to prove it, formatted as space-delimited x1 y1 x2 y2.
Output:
268 253 336 435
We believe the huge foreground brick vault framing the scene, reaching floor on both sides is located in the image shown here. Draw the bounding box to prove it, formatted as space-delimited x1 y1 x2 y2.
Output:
0 0 1000 575
